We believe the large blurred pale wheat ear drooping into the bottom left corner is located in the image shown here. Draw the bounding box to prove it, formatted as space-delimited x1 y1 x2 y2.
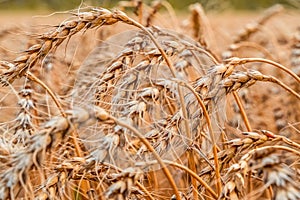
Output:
0 117 69 199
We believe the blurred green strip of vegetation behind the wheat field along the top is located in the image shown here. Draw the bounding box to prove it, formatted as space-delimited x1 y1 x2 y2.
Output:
0 0 300 12
